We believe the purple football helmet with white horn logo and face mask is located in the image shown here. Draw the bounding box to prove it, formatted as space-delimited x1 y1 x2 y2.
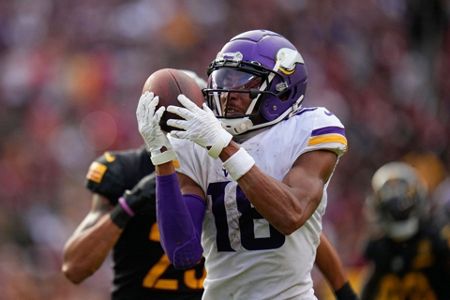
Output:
204 30 307 135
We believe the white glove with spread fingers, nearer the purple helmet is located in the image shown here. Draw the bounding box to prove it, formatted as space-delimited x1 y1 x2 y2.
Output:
167 95 232 158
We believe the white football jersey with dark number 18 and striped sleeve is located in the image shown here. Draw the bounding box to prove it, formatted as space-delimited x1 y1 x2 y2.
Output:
171 107 347 300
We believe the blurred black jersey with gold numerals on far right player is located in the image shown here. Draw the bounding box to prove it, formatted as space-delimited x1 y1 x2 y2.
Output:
361 223 450 300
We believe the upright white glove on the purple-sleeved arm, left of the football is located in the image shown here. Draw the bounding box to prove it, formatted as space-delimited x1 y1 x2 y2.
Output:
136 91 177 166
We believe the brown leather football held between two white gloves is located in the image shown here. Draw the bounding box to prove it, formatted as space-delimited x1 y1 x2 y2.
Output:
142 68 204 132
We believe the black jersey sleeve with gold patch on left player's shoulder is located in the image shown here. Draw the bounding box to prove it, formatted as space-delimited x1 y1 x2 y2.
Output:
85 152 126 205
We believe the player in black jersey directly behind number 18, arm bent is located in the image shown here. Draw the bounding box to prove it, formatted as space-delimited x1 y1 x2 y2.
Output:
62 71 206 300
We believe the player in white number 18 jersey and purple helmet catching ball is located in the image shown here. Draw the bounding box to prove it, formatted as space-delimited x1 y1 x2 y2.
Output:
137 30 347 299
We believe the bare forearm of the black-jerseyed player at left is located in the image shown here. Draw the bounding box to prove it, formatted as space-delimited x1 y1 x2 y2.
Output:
62 214 122 283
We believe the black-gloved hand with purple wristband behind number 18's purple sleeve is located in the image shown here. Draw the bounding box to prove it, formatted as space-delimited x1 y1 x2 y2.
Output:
110 173 156 228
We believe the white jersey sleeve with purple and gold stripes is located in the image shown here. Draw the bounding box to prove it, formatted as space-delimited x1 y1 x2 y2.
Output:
304 107 348 157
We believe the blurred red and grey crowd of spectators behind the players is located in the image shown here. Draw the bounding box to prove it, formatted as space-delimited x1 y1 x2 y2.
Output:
0 0 450 300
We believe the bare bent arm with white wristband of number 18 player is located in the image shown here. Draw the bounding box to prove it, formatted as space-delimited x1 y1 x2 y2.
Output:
220 142 328 235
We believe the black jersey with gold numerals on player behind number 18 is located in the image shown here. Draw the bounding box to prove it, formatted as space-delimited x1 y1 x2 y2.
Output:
86 148 205 300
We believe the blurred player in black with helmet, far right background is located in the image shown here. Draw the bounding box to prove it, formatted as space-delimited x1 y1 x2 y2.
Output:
361 162 450 300
